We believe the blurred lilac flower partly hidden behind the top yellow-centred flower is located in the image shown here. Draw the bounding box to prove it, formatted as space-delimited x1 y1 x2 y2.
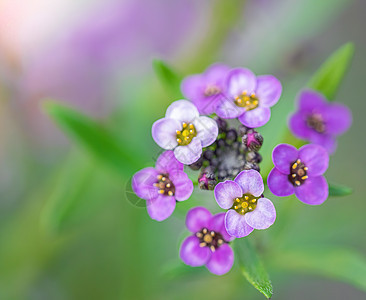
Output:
181 64 230 115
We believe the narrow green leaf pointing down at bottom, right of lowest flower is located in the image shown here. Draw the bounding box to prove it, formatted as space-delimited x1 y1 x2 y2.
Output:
234 238 273 299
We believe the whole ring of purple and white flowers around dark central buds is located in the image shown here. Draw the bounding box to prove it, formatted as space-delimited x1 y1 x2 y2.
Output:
132 64 351 275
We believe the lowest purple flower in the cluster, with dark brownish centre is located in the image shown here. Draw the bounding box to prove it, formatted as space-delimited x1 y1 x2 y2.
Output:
180 207 234 275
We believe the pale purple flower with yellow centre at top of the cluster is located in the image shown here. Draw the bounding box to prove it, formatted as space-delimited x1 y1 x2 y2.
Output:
216 68 282 128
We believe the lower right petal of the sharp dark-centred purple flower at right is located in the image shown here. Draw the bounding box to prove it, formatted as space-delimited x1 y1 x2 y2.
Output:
295 176 328 205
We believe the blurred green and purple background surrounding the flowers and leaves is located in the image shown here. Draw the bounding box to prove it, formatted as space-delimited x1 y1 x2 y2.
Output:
0 0 366 300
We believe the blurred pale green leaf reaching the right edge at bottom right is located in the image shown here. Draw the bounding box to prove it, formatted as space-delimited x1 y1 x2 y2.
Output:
268 245 366 291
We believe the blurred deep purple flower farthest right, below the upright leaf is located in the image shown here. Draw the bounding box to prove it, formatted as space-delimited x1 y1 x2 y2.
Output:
289 90 352 153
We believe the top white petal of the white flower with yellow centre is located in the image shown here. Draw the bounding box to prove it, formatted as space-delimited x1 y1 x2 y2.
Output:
165 100 199 123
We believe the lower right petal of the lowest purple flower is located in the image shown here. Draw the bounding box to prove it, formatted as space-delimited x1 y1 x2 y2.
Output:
206 244 234 275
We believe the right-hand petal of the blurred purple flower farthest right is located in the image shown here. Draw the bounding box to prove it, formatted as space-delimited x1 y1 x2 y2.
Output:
324 103 352 135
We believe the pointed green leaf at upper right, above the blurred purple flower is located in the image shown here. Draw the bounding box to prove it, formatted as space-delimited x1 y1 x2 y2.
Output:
308 43 354 100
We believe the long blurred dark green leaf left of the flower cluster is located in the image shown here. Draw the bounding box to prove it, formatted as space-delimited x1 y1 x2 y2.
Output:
43 101 140 177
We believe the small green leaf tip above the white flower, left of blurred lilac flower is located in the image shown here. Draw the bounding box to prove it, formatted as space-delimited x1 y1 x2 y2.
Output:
153 59 182 98
